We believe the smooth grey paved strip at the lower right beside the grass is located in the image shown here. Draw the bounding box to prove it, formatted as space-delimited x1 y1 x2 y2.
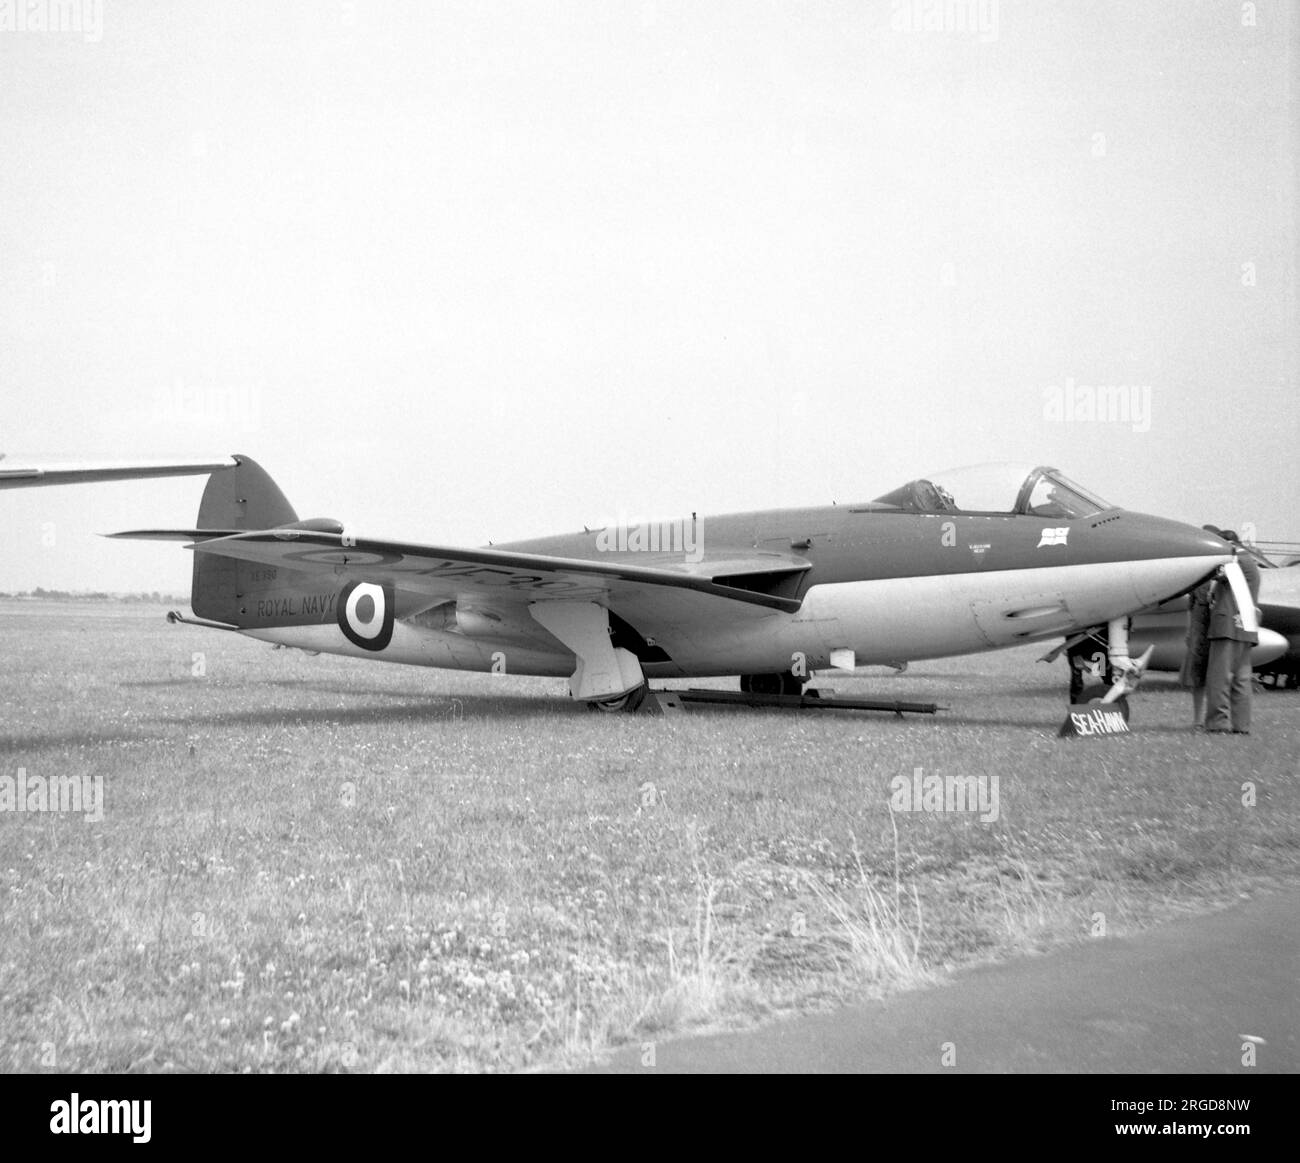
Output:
595 890 1300 1073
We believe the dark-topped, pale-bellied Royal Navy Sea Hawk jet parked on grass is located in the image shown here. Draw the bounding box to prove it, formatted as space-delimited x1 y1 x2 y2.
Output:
112 455 1232 709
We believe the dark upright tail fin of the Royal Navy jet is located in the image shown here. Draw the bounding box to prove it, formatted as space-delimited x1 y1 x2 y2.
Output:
190 455 298 626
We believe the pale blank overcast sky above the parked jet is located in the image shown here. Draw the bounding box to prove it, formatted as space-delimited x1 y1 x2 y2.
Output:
0 0 1300 591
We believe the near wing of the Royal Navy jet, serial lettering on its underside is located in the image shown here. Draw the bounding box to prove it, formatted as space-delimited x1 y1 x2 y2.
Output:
111 529 813 613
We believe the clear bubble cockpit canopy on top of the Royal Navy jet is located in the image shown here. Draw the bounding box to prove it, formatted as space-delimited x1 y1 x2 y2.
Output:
871 464 1114 521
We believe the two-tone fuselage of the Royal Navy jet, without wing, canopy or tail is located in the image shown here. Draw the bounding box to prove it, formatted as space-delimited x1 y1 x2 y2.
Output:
243 504 1227 677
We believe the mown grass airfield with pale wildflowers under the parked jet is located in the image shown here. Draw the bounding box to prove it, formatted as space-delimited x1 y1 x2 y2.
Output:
0 602 1300 1072
